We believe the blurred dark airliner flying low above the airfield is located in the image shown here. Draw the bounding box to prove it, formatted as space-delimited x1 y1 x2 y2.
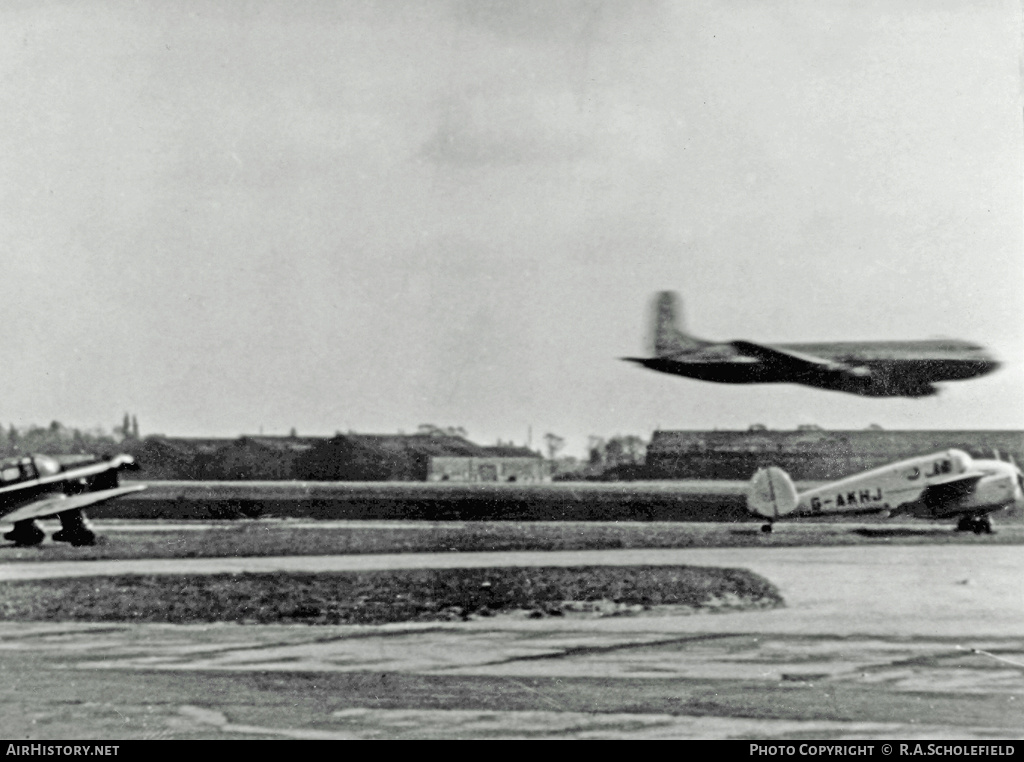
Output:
623 291 999 397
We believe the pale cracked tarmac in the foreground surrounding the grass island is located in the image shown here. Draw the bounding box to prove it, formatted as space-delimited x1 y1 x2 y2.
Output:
0 545 1024 739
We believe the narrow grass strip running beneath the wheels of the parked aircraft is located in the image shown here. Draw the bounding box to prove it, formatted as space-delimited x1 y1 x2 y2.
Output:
0 521 1024 564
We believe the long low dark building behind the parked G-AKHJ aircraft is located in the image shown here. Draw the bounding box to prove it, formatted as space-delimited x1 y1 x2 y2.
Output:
645 427 1024 481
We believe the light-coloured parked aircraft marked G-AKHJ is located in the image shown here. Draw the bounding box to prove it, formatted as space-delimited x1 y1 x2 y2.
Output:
746 450 1024 535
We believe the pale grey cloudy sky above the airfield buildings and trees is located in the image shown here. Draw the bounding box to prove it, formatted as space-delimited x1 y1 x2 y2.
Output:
0 0 1024 455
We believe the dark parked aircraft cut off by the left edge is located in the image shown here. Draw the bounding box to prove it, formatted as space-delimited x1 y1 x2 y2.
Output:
0 455 145 545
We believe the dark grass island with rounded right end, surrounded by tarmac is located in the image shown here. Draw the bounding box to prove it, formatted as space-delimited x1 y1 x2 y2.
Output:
0 566 782 625
